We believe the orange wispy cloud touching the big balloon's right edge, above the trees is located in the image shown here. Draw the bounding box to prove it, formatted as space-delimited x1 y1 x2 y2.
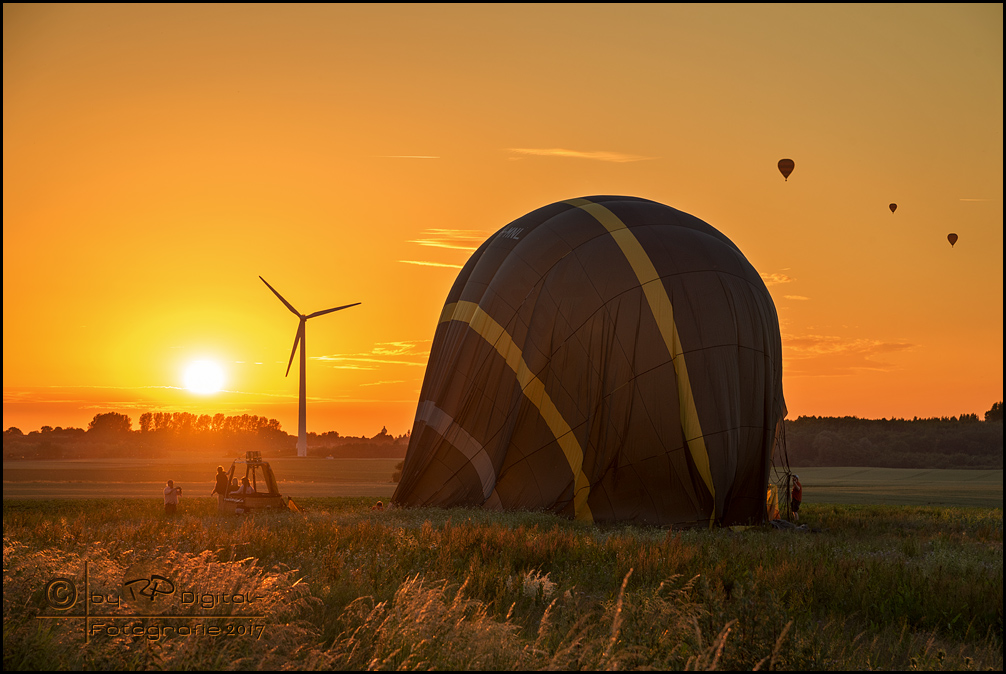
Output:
783 335 916 376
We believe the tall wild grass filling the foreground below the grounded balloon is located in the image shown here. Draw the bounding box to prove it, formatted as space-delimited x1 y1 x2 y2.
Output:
3 499 1003 670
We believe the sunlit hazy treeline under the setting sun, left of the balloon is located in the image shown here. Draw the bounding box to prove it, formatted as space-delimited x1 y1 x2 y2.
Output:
3 412 408 461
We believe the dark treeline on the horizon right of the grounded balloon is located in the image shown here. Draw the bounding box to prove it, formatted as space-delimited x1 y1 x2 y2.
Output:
786 402 1003 469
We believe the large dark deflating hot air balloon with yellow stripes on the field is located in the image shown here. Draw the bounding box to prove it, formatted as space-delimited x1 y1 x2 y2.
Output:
393 196 786 526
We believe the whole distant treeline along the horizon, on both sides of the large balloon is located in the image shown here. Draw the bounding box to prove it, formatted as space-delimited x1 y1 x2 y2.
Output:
3 401 1003 469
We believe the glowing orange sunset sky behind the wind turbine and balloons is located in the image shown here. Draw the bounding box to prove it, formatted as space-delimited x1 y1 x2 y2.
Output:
3 4 1003 436
